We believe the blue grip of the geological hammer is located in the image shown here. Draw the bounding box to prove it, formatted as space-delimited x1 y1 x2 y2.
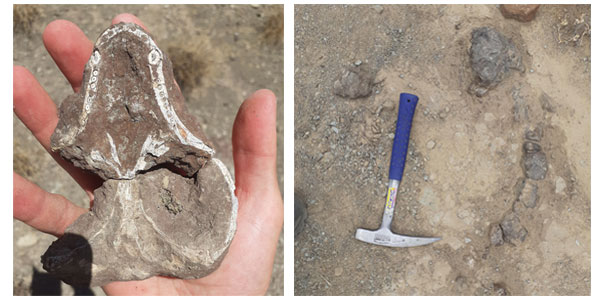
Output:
390 93 419 181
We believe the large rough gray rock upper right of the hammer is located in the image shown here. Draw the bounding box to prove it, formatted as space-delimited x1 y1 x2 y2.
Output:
469 27 522 97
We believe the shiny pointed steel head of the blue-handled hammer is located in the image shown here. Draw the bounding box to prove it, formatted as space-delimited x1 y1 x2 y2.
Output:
354 227 440 247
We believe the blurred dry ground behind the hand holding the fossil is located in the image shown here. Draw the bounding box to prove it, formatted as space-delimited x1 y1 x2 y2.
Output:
13 5 283 295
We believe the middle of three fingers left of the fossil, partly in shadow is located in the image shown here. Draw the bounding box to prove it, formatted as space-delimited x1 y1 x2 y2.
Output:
13 66 102 192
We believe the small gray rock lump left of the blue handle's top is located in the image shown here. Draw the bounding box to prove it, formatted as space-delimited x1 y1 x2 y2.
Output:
333 63 375 99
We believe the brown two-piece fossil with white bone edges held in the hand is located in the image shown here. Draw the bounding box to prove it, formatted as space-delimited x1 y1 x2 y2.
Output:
42 23 237 286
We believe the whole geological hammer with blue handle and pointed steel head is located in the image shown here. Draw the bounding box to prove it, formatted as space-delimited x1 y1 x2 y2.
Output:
354 93 440 247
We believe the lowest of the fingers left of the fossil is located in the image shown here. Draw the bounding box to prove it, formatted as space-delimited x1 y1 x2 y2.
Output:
13 172 86 237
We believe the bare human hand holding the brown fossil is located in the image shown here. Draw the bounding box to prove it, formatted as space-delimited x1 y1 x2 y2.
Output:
13 14 283 295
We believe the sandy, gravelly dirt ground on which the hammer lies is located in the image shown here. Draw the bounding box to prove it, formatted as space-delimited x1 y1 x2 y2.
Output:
294 5 591 295
